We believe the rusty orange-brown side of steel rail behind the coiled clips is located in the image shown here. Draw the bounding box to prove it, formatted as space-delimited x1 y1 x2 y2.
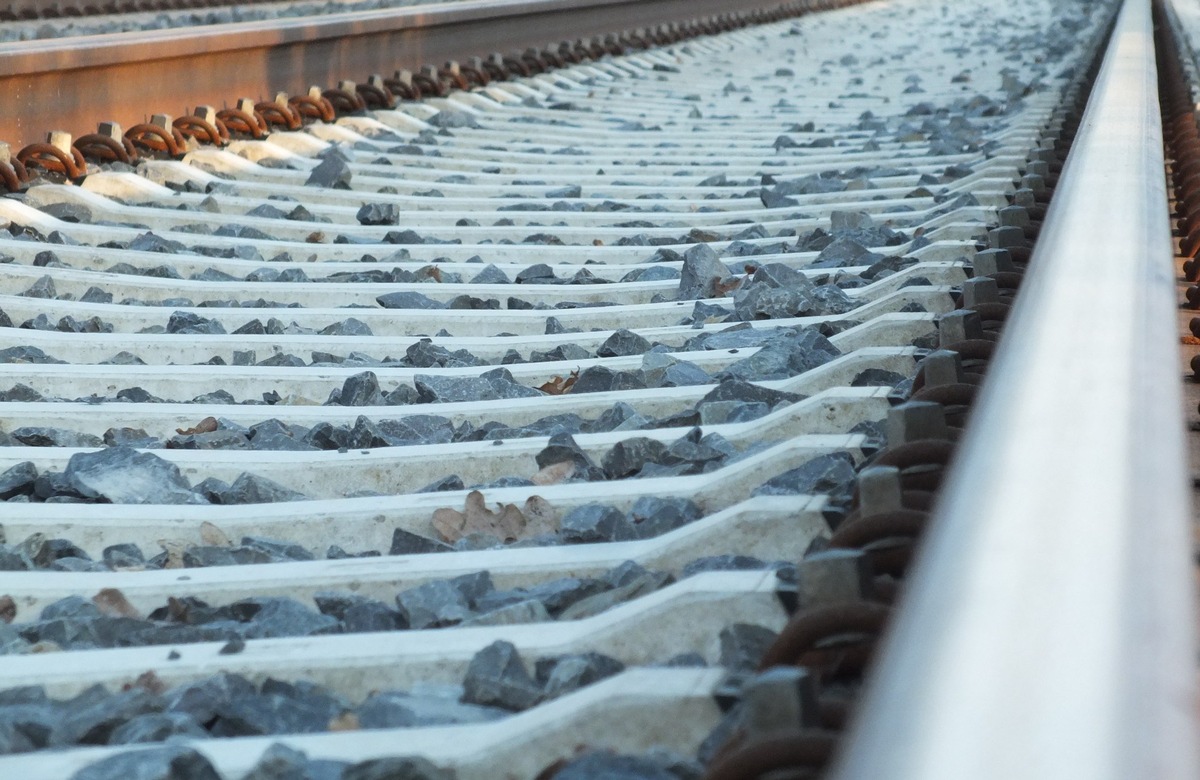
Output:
0 0 846 148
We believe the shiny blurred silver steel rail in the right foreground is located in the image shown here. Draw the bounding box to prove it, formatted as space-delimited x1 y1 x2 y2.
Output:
833 0 1198 780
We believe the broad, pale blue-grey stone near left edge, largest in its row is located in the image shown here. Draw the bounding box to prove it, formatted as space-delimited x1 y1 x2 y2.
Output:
64 446 205 504
